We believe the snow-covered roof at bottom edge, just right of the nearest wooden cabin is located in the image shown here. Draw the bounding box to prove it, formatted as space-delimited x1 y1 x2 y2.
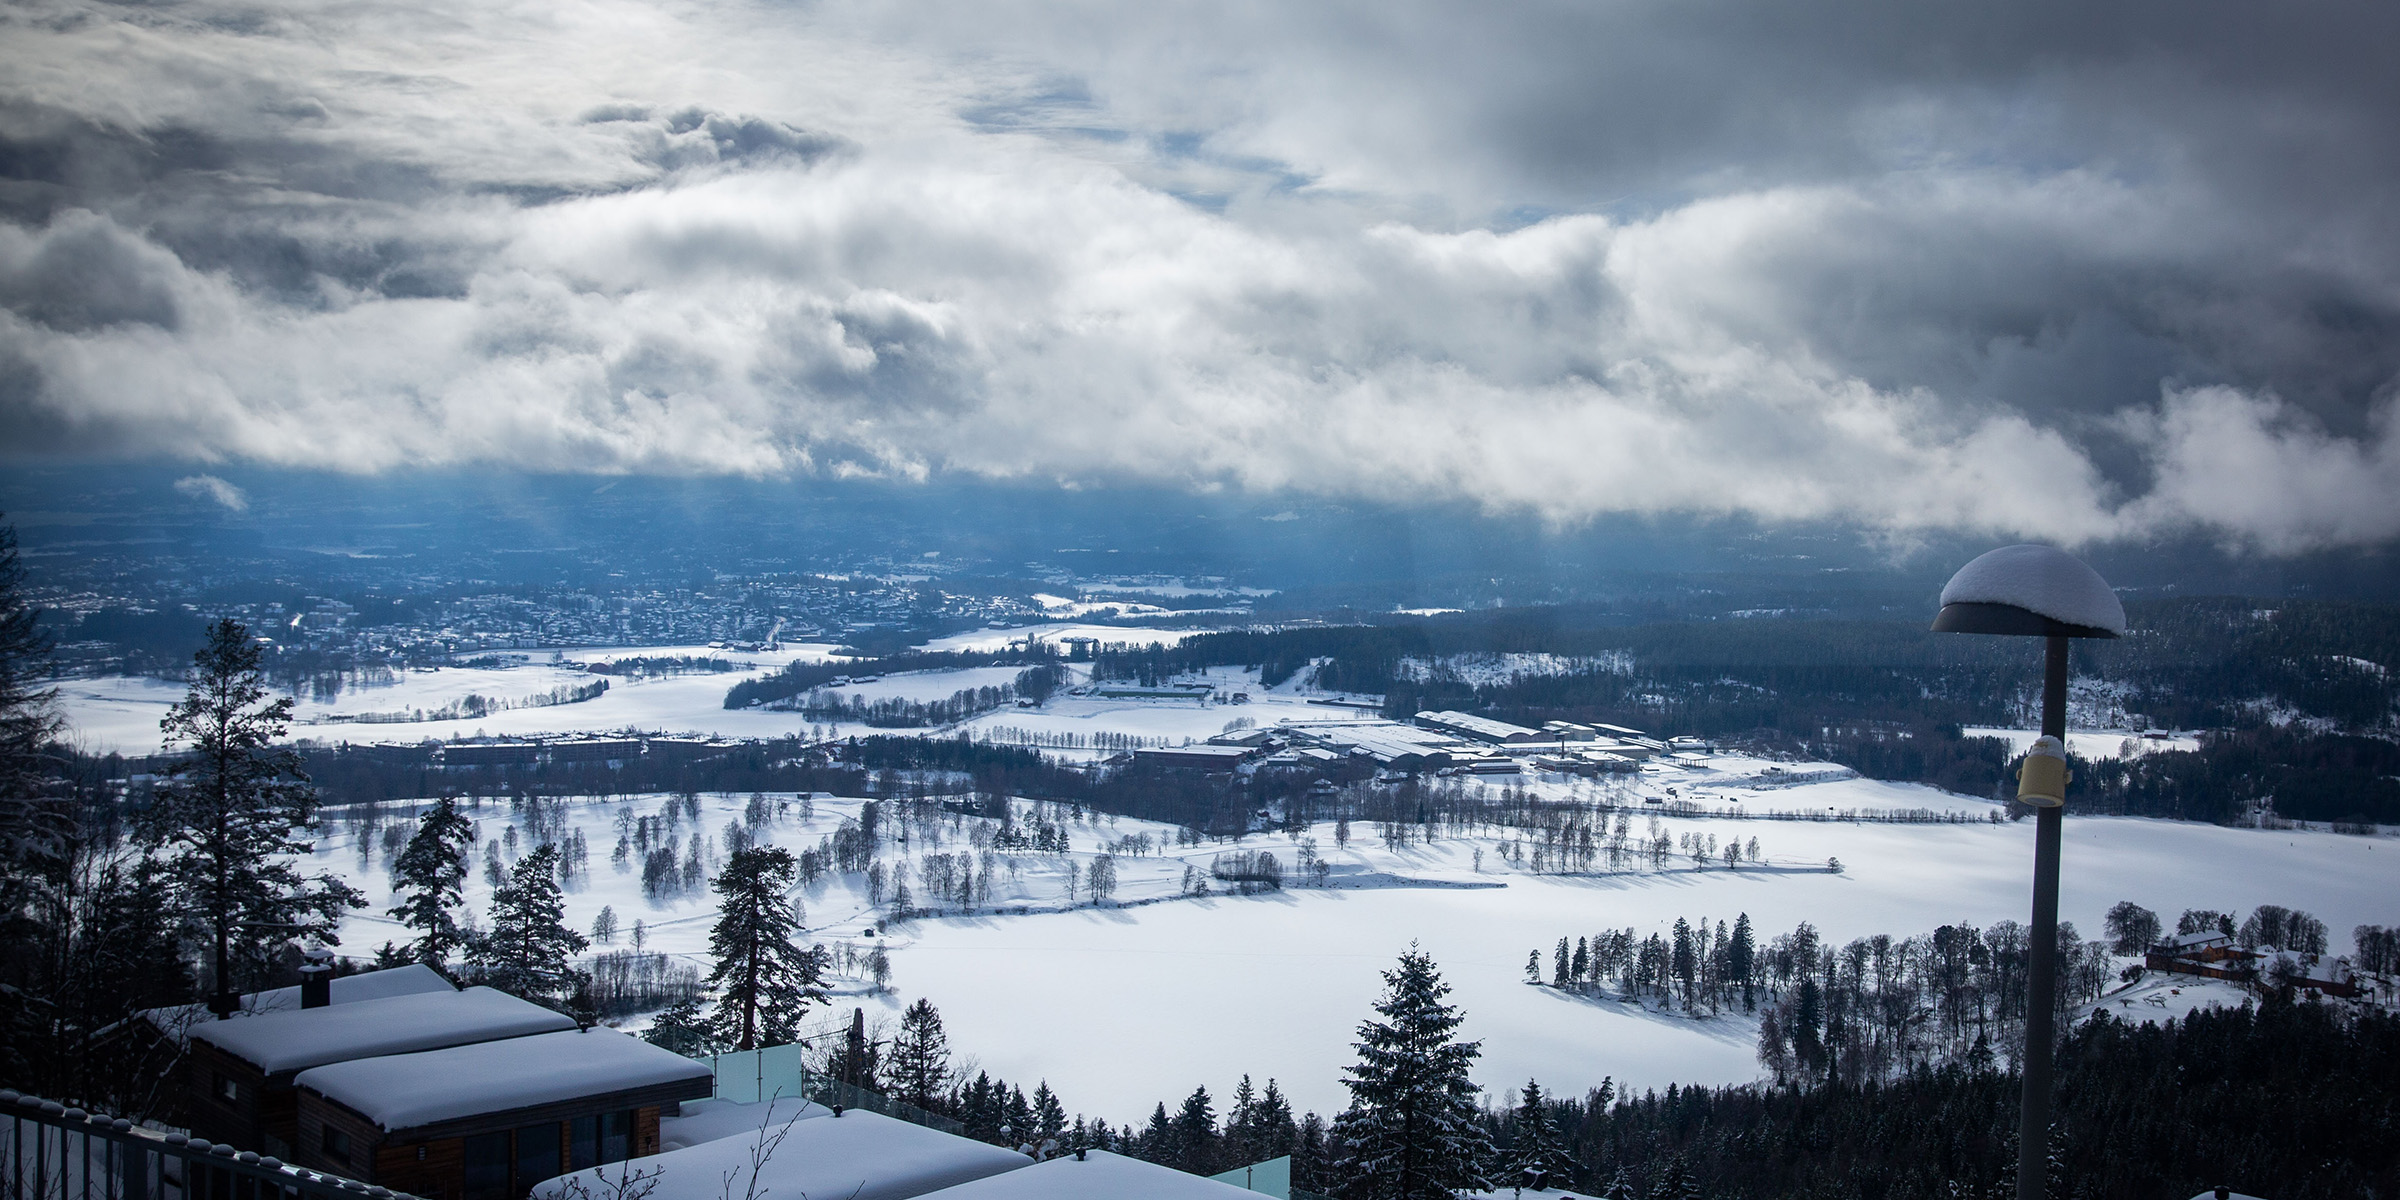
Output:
533 1109 1027 1200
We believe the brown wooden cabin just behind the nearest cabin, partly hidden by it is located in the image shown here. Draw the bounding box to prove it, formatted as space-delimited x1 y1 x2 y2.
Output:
182 972 576 1159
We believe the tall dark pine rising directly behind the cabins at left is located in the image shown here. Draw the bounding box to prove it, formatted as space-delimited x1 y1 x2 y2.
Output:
146 619 367 1015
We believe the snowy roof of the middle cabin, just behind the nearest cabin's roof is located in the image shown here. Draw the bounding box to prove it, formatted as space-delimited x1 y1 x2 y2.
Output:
192 979 576 1075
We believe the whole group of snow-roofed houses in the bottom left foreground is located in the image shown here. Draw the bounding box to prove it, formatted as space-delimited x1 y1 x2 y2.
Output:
144 958 1291 1200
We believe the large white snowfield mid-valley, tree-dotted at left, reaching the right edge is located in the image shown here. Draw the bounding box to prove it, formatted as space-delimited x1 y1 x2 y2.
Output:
319 780 2400 1121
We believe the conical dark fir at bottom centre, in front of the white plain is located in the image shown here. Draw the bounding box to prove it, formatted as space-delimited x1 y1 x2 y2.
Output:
1334 948 1490 1200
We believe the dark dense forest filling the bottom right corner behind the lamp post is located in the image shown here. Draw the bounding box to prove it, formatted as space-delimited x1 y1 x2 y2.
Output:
1486 991 2400 1200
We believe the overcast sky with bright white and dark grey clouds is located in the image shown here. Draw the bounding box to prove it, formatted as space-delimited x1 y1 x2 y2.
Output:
0 0 2400 552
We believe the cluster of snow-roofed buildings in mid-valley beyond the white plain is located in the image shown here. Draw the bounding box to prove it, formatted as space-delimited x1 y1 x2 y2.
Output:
1123 710 1714 778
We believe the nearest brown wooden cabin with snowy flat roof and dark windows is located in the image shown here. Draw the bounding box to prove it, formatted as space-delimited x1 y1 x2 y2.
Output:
293 1027 715 1200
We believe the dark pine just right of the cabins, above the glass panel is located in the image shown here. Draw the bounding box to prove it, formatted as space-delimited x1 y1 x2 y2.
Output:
708 847 828 1051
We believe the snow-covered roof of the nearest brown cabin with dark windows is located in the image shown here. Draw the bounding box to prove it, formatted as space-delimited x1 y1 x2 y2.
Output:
295 1027 715 1130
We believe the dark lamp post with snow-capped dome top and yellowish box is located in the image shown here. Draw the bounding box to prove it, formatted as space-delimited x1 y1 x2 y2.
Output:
1934 545 2124 1200
